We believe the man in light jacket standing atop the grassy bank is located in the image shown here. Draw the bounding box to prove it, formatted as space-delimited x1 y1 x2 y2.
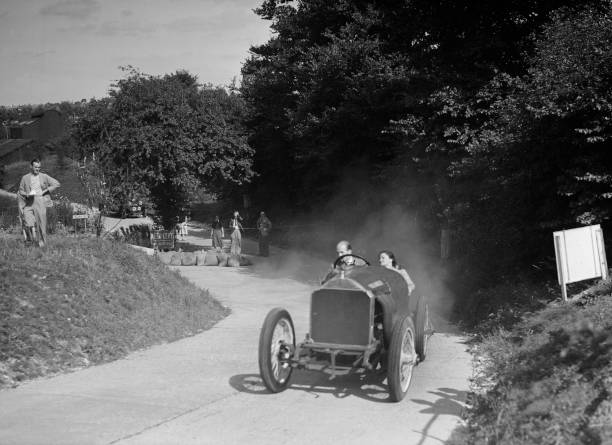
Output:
17 158 60 247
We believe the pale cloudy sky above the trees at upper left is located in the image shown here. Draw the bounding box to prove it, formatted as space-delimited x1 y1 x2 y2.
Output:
0 0 271 106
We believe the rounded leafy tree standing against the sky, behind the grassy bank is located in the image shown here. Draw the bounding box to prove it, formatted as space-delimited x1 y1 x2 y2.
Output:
73 68 253 226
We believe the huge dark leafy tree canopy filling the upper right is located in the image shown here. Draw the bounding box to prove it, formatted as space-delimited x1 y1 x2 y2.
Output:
242 0 612 288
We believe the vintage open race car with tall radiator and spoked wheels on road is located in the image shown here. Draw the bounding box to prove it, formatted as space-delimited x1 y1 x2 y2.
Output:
259 254 433 402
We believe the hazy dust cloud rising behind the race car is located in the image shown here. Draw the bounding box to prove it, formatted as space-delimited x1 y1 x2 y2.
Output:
256 163 454 320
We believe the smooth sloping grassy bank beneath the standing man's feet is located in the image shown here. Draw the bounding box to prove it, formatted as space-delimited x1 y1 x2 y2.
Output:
0 235 228 387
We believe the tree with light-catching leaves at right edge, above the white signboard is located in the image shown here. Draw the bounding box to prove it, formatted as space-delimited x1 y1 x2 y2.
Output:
438 8 612 275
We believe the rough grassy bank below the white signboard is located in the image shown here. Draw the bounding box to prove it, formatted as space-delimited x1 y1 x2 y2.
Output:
453 280 612 445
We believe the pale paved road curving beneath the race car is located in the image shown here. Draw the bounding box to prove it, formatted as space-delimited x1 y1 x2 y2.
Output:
0 234 471 445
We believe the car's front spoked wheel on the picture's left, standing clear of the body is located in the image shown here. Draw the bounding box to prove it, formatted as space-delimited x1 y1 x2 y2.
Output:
259 308 295 392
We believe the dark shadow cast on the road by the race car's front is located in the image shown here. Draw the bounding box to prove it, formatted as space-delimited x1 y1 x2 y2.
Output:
229 370 391 403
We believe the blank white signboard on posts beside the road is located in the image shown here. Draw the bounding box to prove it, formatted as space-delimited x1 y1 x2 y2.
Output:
553 224 608 299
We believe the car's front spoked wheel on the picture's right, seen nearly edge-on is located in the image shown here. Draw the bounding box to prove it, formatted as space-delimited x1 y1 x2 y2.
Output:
387 316 417 402
